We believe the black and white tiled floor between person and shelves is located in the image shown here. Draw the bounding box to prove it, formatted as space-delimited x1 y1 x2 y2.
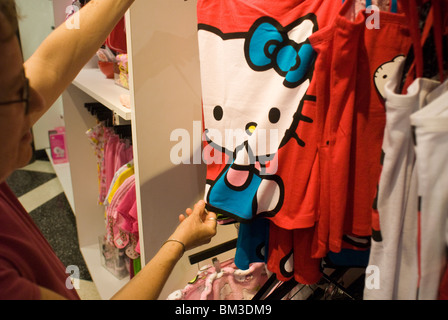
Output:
7 160 101 300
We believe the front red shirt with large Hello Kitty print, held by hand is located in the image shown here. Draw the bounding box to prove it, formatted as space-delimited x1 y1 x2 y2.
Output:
198 1 341 286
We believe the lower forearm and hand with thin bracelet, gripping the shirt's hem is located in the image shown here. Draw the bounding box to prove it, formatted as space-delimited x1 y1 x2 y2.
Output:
112 201 217 300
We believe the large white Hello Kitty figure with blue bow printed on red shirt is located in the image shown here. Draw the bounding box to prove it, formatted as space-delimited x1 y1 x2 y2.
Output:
198 14 317 222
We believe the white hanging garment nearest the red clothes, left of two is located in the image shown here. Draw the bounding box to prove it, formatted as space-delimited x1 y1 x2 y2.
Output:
364 60 439 300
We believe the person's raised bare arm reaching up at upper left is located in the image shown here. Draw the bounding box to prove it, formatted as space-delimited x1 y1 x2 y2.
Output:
24 0 134 124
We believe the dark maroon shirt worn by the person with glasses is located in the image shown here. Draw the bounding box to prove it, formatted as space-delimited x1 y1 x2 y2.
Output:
0 183 79 300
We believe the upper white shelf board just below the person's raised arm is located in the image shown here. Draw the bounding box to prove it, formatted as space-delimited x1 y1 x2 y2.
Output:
73 68 131 120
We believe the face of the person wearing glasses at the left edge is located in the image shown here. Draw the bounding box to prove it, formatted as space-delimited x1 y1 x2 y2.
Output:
0 20 43 182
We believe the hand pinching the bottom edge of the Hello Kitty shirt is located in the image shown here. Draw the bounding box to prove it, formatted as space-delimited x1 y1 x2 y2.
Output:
169 200 217 250
